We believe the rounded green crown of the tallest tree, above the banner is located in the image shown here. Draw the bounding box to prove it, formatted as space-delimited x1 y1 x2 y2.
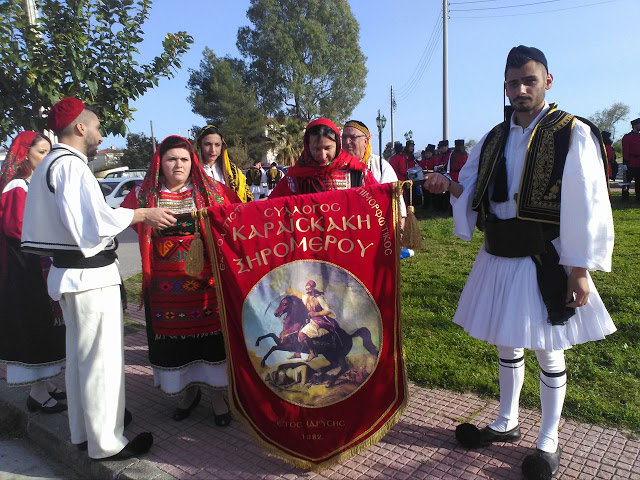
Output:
237 0 367 123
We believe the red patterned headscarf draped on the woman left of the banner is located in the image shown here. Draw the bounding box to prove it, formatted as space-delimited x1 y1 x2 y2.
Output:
122 135 231 290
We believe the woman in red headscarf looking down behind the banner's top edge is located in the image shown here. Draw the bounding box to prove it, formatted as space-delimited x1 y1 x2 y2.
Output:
269 118 378 198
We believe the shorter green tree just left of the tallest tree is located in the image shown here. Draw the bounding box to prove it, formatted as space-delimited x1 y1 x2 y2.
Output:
188 48 266 161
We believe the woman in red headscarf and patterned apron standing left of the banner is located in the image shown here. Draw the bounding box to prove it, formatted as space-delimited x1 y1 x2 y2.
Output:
122 136 239 427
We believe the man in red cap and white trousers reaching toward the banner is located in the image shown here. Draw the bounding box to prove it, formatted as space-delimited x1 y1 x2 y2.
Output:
22 98 176 460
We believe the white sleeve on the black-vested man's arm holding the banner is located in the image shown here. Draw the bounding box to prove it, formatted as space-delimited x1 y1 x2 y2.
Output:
450 134 488 242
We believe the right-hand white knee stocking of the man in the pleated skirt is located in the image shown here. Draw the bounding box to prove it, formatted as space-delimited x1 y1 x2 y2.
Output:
536 350 567 452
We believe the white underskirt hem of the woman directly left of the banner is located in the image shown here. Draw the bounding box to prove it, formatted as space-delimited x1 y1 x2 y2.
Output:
153 362 228 395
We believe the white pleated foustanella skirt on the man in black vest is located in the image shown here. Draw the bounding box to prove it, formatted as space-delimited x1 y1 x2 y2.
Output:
453 245 616 350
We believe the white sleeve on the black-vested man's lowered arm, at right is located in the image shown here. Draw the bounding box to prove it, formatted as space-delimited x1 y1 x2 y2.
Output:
557 120 614 272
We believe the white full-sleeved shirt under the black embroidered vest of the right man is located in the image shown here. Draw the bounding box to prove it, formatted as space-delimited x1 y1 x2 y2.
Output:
451 102 614 272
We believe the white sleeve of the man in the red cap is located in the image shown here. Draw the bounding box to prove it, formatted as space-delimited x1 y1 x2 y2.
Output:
51 158 134 257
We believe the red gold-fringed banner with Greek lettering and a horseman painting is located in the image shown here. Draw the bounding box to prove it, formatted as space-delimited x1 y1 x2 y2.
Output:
202 184 408 469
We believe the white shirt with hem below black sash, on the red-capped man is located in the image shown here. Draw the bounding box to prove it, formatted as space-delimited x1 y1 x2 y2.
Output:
41 144 134 300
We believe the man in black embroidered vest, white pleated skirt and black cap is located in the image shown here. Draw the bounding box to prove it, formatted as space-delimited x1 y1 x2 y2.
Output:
425 45 616 479
